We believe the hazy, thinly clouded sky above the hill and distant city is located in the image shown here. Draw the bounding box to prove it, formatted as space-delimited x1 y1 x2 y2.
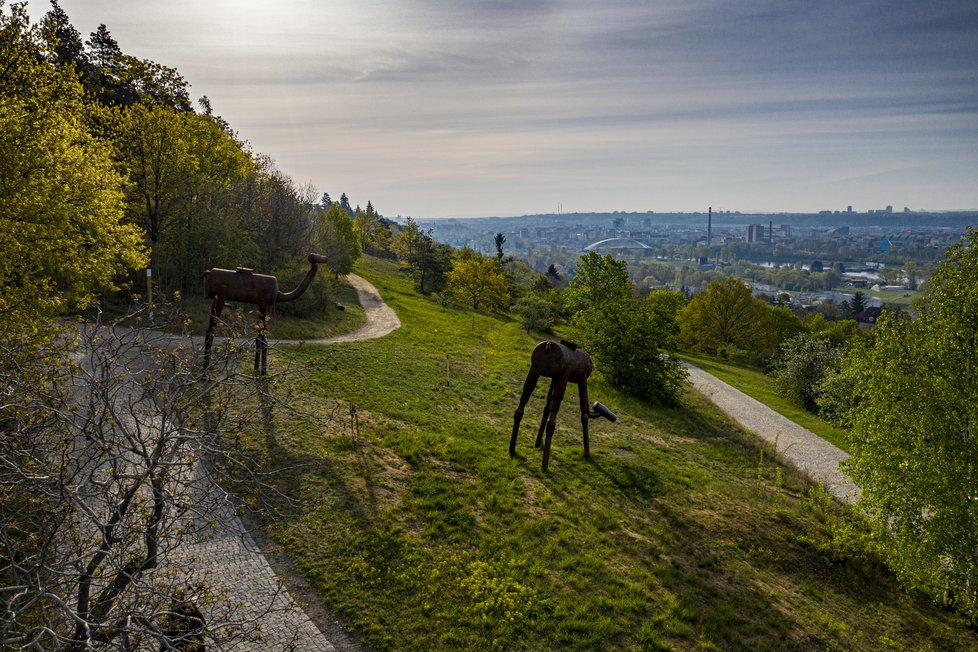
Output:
29 0 978 217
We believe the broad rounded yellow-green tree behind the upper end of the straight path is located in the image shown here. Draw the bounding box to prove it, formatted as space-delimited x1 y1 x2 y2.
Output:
678 277 774 360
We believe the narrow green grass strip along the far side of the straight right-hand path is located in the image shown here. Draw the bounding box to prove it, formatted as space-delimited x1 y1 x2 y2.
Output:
681 353 847 450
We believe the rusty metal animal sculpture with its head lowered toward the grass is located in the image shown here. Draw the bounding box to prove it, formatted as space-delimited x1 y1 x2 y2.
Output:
509 340 618 471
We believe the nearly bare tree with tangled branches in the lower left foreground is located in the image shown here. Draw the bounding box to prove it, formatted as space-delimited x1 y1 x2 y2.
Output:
0 308 332 652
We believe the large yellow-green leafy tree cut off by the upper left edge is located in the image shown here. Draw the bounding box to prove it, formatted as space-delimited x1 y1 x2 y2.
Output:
0 5 145 340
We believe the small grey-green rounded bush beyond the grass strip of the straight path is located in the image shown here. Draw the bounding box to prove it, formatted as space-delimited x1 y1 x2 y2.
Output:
772 333 841 412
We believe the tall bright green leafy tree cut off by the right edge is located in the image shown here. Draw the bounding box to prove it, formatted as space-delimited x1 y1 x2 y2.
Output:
844 229 978 618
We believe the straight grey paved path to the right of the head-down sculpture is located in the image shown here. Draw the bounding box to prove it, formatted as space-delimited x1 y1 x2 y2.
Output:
686 363 860 503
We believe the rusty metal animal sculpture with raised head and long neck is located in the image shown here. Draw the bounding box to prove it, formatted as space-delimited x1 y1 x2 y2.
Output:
204 254 326 375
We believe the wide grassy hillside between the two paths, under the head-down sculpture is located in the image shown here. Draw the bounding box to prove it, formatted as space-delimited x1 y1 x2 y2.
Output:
241 260 978 650
